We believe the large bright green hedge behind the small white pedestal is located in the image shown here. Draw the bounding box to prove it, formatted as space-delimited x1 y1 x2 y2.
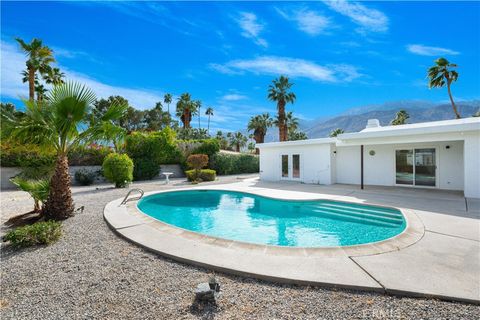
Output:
125 128 182 180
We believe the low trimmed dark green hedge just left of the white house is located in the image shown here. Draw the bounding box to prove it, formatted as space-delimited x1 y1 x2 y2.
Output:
209 153 260 175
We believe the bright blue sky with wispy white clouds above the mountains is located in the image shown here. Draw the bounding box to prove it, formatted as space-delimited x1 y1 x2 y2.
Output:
1 1 480 130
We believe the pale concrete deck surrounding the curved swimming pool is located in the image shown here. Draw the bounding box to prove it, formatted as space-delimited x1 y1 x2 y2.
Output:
104 179 480 304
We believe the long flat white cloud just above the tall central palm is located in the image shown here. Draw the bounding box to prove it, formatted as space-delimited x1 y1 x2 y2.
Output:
211 56 362 82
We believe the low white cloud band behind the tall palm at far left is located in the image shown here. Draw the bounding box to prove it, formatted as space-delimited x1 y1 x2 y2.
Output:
0 41 163 109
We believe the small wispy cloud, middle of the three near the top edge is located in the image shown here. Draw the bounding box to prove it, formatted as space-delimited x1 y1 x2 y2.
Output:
276 8 332 36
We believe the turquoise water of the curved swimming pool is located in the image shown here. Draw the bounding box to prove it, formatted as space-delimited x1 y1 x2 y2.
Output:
138 190 406 247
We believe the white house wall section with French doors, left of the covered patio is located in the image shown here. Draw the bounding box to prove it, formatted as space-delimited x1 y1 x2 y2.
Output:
260 143 335 184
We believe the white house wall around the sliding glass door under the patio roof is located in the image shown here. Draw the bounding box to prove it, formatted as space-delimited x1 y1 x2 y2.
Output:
336 141 464 190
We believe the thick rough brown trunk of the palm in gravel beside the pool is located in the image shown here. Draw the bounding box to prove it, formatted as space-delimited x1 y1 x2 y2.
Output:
45 154 74 220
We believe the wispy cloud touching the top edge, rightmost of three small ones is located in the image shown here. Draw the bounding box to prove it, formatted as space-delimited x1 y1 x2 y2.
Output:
324 0 388 33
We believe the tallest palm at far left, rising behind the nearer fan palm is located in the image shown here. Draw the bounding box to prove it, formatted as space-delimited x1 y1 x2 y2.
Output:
15 38 55 101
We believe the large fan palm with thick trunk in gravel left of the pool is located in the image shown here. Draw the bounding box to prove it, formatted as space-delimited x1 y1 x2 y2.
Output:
14 83 126 220
